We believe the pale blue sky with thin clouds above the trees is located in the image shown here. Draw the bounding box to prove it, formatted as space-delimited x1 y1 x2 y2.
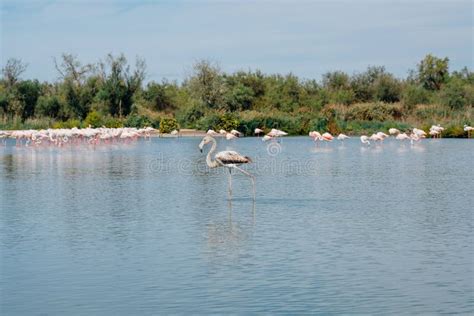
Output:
0 0 474 81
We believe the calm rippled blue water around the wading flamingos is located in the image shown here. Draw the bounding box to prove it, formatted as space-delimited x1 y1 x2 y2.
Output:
0 137 474 315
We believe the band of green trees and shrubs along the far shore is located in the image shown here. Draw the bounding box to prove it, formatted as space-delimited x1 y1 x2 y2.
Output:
0 54 474 137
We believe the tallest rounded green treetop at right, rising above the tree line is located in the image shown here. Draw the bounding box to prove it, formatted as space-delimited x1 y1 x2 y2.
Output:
417 54 449 90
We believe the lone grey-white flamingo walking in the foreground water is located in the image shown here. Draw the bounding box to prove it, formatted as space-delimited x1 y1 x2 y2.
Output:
199 136 255 200
